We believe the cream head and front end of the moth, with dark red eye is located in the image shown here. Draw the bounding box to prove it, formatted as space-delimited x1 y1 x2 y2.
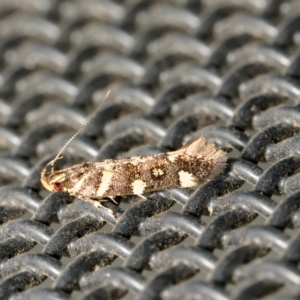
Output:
41 165 85 192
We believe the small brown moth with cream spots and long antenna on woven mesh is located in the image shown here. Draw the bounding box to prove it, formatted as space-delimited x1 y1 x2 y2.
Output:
41 92 227 208
